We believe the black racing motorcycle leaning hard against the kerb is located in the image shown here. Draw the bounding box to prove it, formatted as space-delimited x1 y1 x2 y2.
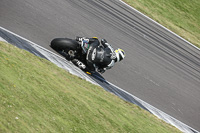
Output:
50 38 95 74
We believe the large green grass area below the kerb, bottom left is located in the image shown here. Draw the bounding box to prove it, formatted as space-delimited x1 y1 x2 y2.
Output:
0 42 180 133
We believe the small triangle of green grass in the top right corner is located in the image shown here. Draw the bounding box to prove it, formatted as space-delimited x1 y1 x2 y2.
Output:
123 0 200 47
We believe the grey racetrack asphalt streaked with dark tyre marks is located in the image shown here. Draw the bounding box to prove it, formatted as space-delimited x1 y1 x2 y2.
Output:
0 0 200 131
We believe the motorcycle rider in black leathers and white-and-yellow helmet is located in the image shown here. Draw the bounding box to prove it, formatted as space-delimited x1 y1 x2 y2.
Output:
72 37 125 73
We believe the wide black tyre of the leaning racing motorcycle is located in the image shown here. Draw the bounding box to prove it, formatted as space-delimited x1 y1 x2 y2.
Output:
50 38 79 51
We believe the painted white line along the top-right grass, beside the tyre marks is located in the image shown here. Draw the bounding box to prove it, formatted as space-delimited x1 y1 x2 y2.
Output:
119 0 200 50
